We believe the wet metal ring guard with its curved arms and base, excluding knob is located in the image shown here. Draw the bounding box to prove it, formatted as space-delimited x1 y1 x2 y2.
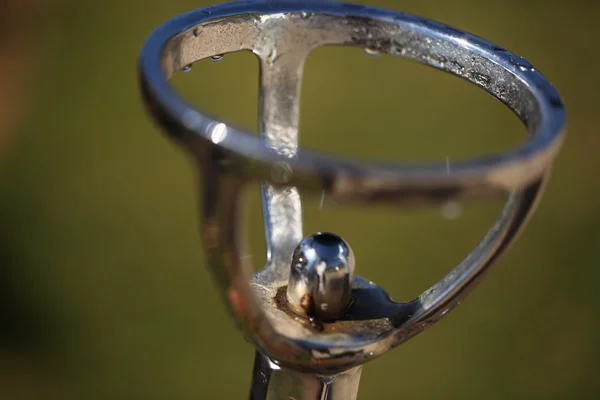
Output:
139 1 565 396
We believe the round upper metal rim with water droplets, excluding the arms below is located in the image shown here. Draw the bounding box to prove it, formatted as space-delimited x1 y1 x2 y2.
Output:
139 1 565 206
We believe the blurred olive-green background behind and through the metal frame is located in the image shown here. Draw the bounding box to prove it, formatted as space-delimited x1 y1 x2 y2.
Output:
0 0 600 399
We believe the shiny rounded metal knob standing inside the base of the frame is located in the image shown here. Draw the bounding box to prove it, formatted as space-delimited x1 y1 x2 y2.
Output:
286 233 355 321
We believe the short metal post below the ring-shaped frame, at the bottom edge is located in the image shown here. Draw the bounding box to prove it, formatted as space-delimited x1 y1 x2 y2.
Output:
250 353 362 400
